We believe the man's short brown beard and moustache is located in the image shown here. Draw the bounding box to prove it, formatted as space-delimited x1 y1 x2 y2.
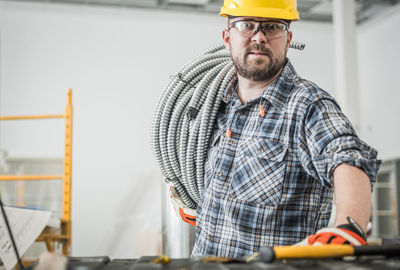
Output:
231 43 286 81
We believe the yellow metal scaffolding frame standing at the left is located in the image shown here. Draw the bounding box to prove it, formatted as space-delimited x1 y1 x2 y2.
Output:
0 89 72 255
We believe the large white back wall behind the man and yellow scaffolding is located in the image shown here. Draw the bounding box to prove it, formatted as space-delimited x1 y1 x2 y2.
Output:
0 2 384 258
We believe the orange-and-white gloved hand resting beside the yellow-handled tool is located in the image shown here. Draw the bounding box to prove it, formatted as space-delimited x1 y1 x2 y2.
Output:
296 217 367 246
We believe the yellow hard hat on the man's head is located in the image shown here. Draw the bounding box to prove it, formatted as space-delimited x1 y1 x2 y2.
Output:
219 0 300 21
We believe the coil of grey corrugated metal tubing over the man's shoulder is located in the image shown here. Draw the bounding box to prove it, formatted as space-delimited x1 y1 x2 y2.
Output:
151 41 304 209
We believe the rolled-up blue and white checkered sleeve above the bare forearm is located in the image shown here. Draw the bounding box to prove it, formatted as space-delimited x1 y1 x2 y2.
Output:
297 99 381 188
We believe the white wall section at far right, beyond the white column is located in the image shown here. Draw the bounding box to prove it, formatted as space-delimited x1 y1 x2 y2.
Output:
358 5 400 160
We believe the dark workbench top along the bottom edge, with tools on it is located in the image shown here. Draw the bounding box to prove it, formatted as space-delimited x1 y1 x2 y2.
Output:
61 255 400 270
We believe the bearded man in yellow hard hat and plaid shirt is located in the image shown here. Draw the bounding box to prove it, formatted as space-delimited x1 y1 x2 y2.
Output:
192 0 380 257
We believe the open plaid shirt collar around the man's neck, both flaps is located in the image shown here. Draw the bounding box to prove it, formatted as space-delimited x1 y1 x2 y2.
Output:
222 58 298 107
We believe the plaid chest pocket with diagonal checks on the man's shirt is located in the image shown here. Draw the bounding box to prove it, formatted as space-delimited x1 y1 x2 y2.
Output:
230 139 287 206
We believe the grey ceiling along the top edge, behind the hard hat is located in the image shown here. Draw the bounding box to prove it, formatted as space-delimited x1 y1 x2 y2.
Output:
0 0 400 23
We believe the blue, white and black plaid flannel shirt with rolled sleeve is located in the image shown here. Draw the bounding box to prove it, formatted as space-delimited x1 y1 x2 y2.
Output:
192 60 380 257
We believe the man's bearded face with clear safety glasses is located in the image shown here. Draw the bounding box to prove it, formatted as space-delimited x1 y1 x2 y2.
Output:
223 17 292 81
